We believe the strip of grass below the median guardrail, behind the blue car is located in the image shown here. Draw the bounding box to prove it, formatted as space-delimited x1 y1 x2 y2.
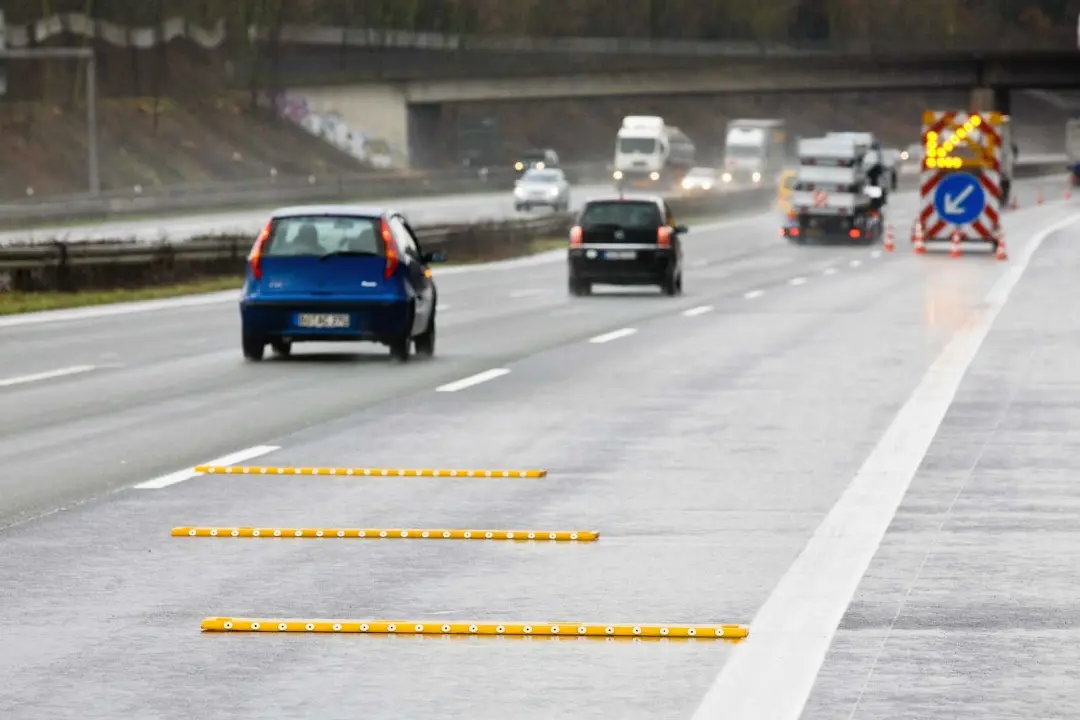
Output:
0 237 566 315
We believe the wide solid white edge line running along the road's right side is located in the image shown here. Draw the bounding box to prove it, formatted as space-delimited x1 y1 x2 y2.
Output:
693 209 1080 720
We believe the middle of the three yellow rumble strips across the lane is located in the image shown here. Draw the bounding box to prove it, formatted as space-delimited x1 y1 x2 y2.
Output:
170 526 600 543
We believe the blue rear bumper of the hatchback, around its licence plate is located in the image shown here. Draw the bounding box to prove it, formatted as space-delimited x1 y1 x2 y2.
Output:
240 298 411 342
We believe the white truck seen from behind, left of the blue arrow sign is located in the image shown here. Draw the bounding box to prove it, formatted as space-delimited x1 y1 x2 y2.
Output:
784 135 886 244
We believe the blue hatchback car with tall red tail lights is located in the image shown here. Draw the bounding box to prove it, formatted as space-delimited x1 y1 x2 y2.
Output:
240 205 446 361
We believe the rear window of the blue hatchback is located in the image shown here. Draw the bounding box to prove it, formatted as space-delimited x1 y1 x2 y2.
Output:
262 215 383 257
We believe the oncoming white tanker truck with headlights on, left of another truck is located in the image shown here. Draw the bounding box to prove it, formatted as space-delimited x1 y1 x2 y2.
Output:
612 116 697 190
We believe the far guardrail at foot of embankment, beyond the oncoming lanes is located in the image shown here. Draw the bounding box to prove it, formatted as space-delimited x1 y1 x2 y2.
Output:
0 163 610 228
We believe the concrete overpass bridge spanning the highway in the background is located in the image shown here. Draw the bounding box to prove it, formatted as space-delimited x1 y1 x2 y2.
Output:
296 50 1080 167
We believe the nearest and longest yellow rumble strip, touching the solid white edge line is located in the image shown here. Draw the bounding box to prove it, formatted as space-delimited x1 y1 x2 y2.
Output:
202 617 750 640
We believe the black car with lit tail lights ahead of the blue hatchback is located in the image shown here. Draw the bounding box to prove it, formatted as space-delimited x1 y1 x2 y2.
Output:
567 196 687 296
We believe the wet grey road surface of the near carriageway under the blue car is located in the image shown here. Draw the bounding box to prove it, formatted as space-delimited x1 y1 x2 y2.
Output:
0 175 1080 720
